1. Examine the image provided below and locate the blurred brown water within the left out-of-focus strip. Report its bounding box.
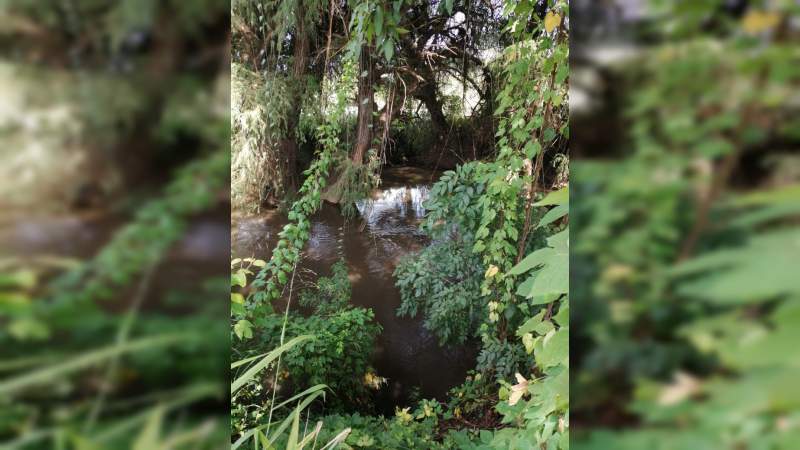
[0,207,230,312]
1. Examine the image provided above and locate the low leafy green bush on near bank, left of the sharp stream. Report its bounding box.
[232,260,380,433]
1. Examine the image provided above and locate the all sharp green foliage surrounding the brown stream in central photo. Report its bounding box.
[231,0,569,449]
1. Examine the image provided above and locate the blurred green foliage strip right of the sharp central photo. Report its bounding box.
[570,0,800,450]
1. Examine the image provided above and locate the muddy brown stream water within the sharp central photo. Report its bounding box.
[231,168,476,413]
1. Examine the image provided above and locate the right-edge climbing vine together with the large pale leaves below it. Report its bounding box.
[473,1,569,448]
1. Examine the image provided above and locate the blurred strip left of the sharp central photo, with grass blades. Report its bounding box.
[0,0,230,449]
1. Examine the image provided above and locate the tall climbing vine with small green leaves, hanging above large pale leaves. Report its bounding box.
[473,1,569,333]
